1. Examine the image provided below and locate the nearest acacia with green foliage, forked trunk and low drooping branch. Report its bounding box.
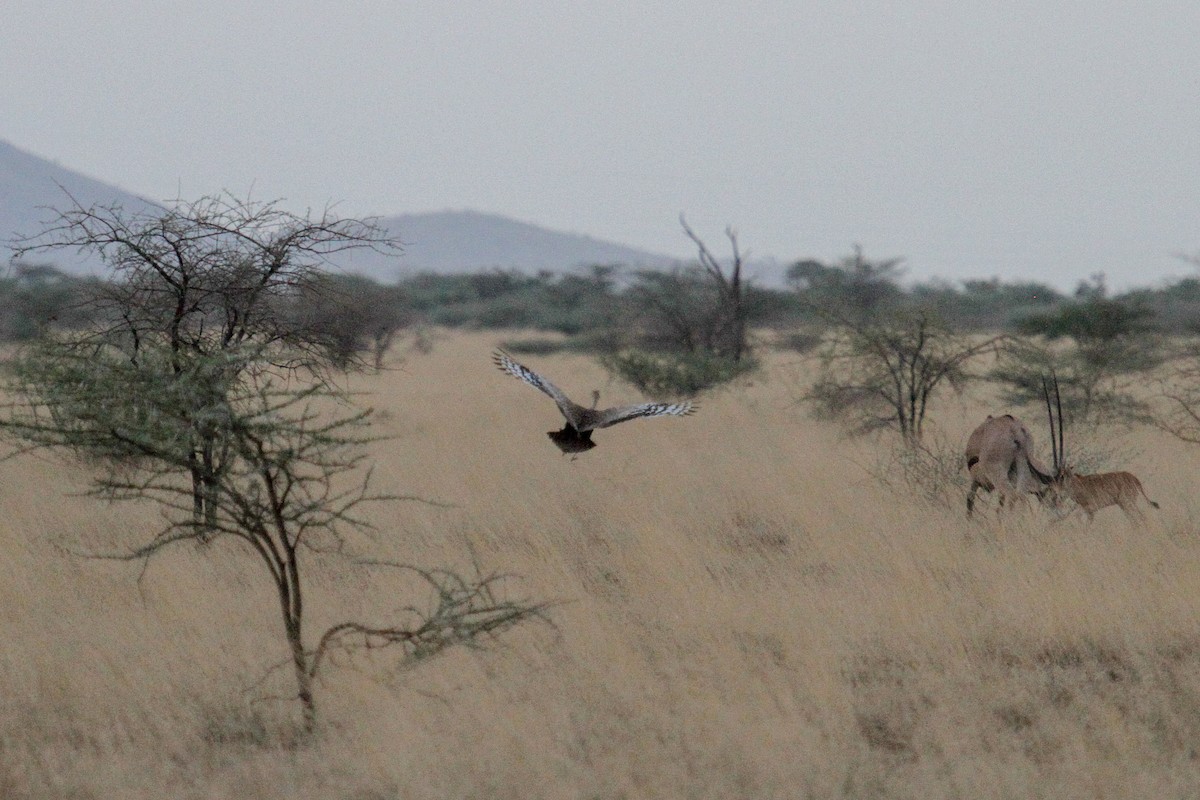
[0,342,544,730]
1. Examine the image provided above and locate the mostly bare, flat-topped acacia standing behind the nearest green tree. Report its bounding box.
[13,194,400,527]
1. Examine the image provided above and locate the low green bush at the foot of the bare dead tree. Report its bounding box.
[600,350,757,401]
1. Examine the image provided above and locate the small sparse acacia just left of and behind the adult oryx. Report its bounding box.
[804,311,1006,445]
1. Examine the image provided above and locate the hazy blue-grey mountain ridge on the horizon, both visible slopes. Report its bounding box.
[0,140,678,283]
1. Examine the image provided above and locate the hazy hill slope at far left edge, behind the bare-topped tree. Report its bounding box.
[0,140,159,271]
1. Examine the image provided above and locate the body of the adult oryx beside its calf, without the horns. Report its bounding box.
[966,414,1054,517]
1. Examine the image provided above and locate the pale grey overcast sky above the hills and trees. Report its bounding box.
[0,0,1200,288]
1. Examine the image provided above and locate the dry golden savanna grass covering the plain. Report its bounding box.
[7,333,1200,800]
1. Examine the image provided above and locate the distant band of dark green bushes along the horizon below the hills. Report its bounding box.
[28,241,1200,352]
